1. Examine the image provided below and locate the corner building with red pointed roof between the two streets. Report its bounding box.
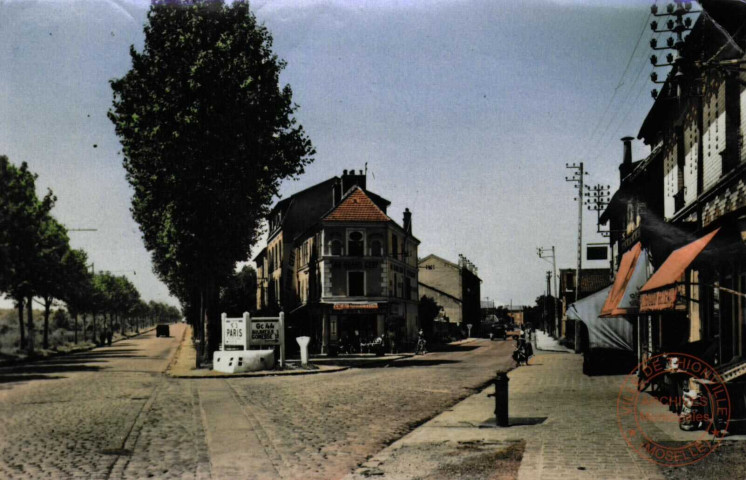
[256,171,419,352]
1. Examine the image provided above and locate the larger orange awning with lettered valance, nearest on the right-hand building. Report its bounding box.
[640,228,720,313]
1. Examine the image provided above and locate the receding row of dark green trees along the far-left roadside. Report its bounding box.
[0,156,181,353]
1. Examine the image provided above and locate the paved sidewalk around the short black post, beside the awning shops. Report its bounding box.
[346,348,672,480]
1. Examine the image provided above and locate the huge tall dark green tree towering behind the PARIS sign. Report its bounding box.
[109,0,314,363]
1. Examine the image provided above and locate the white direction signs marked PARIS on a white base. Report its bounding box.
[213,312,285,373]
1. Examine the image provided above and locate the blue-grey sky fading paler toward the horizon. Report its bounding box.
[0,0,654,305]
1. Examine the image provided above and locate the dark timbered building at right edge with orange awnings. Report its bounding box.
[602,0,746,374]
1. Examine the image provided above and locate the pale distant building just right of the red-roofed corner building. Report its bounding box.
[419,255,482,332]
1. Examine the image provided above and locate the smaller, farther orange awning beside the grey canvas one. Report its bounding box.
[600,242,648,317]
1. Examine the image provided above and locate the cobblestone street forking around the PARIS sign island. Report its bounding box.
[0,325,512,478]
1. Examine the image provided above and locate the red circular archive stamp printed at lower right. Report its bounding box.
[617,353,731,467]
